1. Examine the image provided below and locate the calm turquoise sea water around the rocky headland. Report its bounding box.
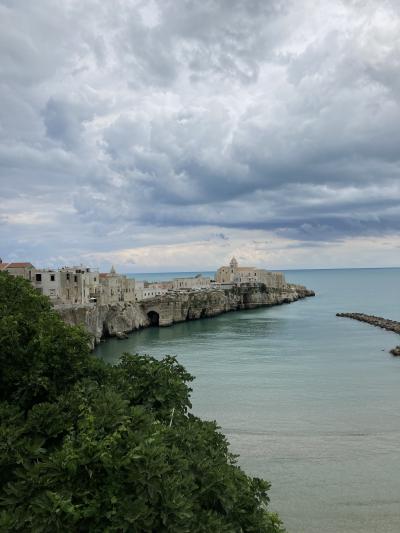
[97,269,400,533]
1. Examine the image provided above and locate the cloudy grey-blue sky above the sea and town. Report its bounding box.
[0,0,400,272]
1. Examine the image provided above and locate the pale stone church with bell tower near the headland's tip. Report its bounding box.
[215,257,286,288]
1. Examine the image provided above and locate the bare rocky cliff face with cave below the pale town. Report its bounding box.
[55,284,315,347]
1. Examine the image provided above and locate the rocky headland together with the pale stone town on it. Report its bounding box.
[0,258,314,347]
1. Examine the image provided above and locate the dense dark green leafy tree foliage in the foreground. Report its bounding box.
[0,273,283,533]
